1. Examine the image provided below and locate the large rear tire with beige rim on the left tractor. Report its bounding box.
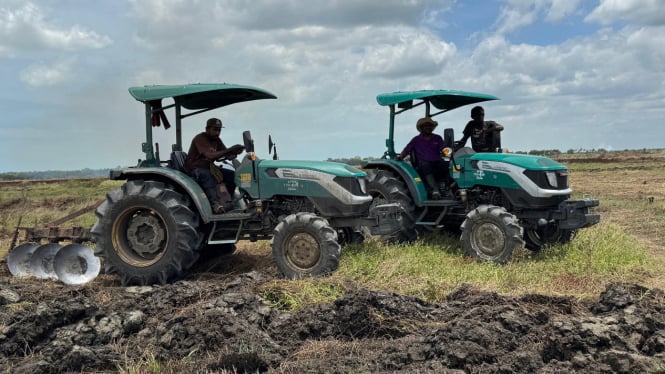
[92,180,202,286]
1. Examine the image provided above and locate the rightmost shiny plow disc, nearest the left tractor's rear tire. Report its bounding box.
[53,244,101,284]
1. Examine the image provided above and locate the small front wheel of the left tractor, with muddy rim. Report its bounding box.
[270,213,341,279]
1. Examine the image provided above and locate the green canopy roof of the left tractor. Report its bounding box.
[129,83,277,110]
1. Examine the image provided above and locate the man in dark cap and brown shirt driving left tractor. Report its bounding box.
[185,118,245,214]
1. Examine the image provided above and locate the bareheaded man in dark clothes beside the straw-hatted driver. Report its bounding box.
[455,106,503,152]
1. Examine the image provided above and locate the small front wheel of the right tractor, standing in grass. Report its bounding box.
[461,205,524,264]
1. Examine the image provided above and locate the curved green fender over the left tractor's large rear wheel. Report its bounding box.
[109,167,212,223]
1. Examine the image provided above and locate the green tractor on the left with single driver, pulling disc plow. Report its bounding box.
[91,84,401,285]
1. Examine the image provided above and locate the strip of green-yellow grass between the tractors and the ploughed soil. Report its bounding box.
[256,224,662,311]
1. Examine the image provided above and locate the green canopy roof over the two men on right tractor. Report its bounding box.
[376,90,499,112]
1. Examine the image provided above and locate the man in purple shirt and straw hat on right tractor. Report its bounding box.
[396,117,450,200]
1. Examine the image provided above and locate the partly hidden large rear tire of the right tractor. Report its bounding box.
[367,169,418,243]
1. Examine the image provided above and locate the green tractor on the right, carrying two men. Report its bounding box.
[365,90,600,263]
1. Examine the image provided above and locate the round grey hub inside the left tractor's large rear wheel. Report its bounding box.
[127,213,165,257]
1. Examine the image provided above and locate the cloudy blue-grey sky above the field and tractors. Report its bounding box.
[0,0,665,172]
